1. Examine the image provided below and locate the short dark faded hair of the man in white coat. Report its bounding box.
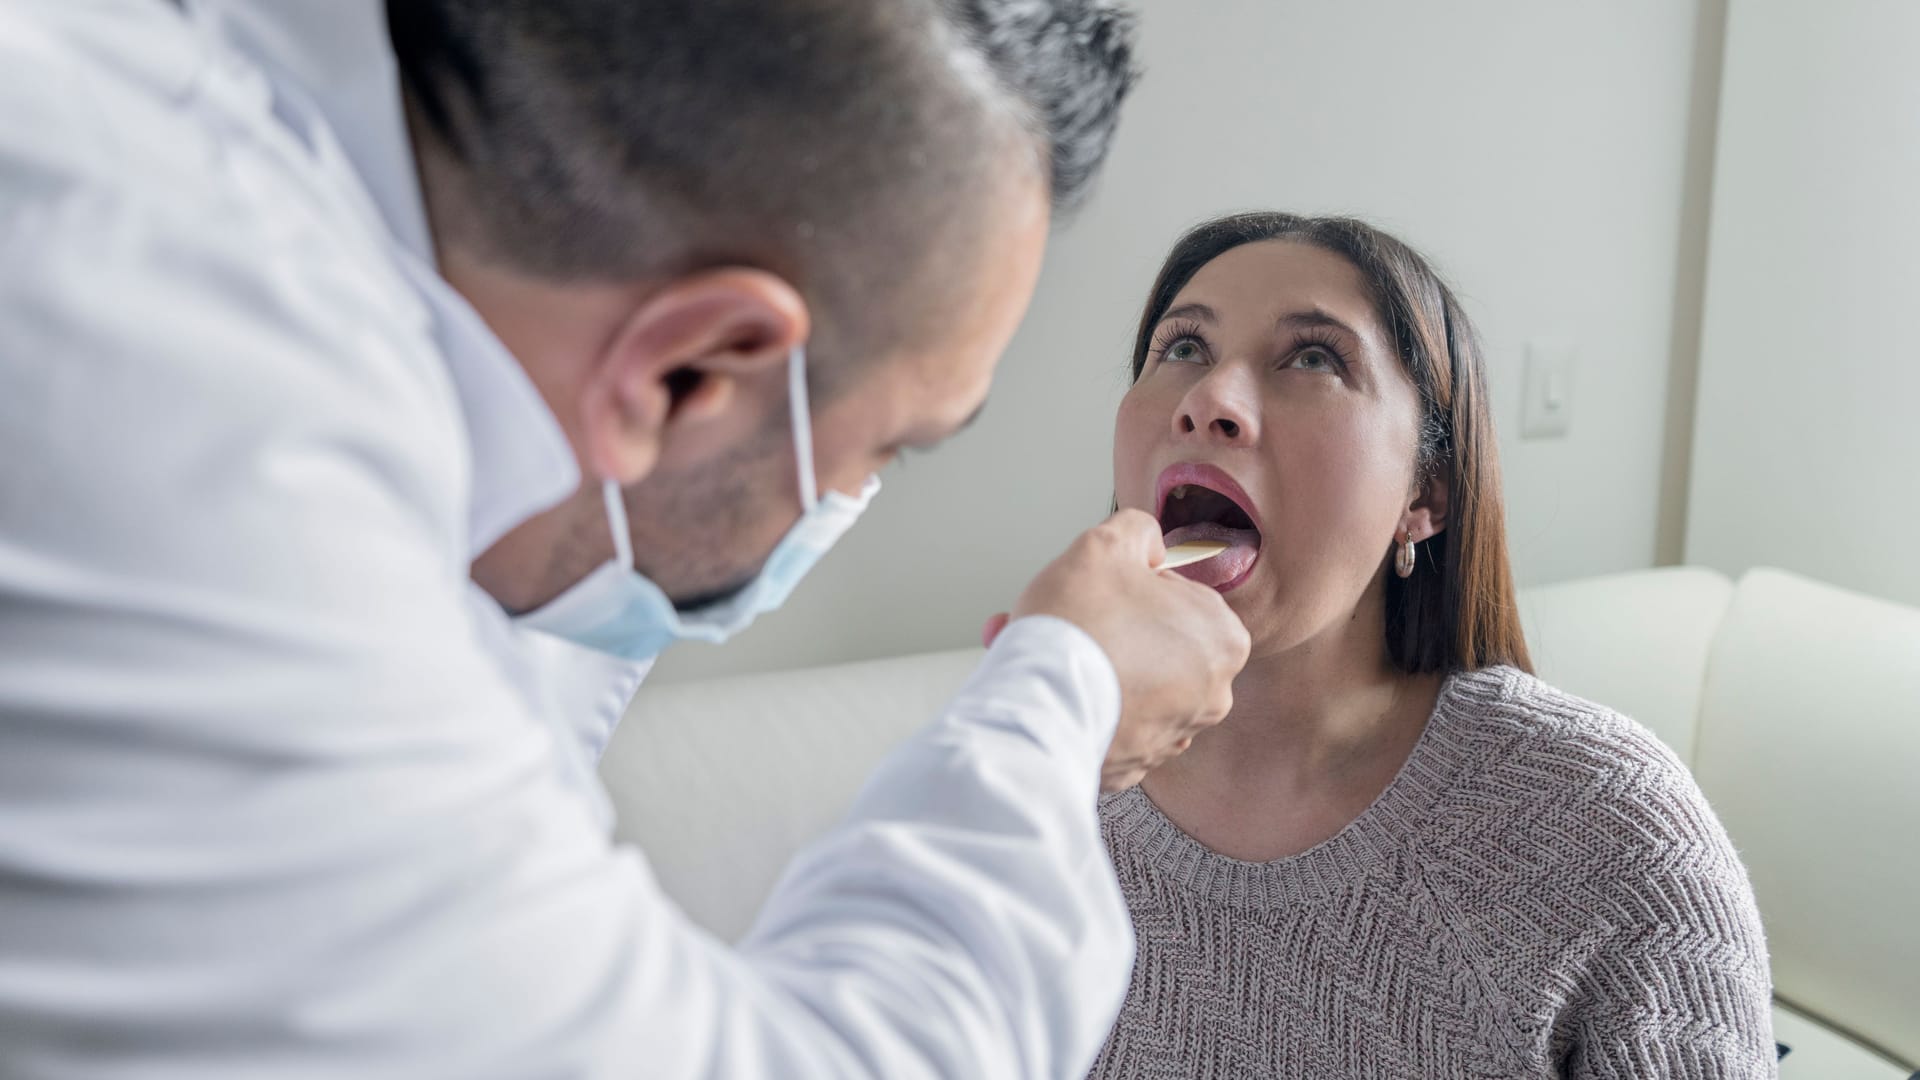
[388,0,1135,374]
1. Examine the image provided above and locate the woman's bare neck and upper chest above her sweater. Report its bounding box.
[1144,588,1442,861]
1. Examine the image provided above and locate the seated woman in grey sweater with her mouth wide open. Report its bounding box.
[1092,213,1774,1080]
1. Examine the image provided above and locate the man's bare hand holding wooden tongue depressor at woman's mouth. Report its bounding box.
[985,509,1252,792]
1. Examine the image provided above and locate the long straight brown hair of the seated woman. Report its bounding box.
[1133,211,1532,673]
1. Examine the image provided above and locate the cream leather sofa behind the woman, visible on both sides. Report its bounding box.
[601,567,1920,1080]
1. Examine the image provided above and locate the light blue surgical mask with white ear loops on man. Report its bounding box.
[518,348,879,659]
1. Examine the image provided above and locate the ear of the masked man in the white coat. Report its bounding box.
[580,267,808,486]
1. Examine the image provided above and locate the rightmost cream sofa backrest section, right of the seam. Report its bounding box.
[1693,571,1920,1061]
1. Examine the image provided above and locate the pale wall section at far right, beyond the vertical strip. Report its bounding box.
[1688,0,1920,603]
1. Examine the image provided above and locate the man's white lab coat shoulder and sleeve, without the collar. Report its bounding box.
[0,16,1131,1080]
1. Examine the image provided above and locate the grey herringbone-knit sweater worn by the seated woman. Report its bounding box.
[1092,667,1776,1080]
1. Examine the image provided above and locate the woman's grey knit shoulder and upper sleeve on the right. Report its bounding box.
[1413,669,1770,1063]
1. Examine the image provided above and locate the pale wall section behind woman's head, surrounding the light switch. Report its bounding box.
[655,0,1718,680]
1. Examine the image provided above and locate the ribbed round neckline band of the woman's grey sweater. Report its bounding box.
[1102,667,1519,907]
